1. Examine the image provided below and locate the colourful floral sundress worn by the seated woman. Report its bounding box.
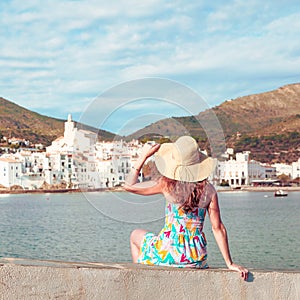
[138,202,208,269]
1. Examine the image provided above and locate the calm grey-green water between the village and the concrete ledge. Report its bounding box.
[0,192,300,269]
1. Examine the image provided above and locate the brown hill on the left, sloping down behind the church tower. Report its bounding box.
[0,97,115,146]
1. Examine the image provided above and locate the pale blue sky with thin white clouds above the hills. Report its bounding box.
[0,0,300,134]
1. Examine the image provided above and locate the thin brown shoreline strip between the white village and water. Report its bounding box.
[0,186,300,195]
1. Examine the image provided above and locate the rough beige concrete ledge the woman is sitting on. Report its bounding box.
[0,259,300,300]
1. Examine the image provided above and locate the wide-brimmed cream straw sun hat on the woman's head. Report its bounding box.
[155,136,217,182]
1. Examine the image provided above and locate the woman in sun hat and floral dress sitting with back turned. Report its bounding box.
[124,136,248,280]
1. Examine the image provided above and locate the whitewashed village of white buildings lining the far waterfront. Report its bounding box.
[0,115,300,190]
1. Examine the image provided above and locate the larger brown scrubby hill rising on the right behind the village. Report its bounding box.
[130,84,300,163]
